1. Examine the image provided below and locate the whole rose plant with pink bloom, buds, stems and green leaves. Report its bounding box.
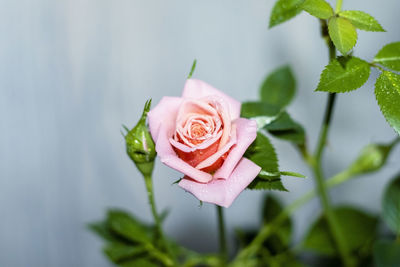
[90,0,400,267]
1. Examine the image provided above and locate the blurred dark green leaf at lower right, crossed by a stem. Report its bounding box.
[303,207,378,256]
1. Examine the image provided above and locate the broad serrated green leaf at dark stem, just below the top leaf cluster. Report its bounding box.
[316,57,371,93]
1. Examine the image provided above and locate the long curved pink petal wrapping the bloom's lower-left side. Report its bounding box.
[156,124,212,183]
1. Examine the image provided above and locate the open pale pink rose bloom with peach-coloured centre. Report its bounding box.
[148,79,261,207]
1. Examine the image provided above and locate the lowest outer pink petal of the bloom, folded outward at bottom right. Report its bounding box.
[179,158,261,208]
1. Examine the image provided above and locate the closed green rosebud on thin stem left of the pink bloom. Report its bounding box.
[125,100,156,176]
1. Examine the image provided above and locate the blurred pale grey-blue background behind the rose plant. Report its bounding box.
[0,0,400,267]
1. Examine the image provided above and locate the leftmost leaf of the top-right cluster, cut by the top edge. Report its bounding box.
[269,0,304,28]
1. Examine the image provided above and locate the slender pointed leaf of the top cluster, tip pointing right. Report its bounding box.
[339,10,385,32]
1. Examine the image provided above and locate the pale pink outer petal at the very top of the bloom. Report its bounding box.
[182,79,241,120]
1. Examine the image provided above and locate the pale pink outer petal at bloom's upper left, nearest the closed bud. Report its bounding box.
[147,96,182,142]
